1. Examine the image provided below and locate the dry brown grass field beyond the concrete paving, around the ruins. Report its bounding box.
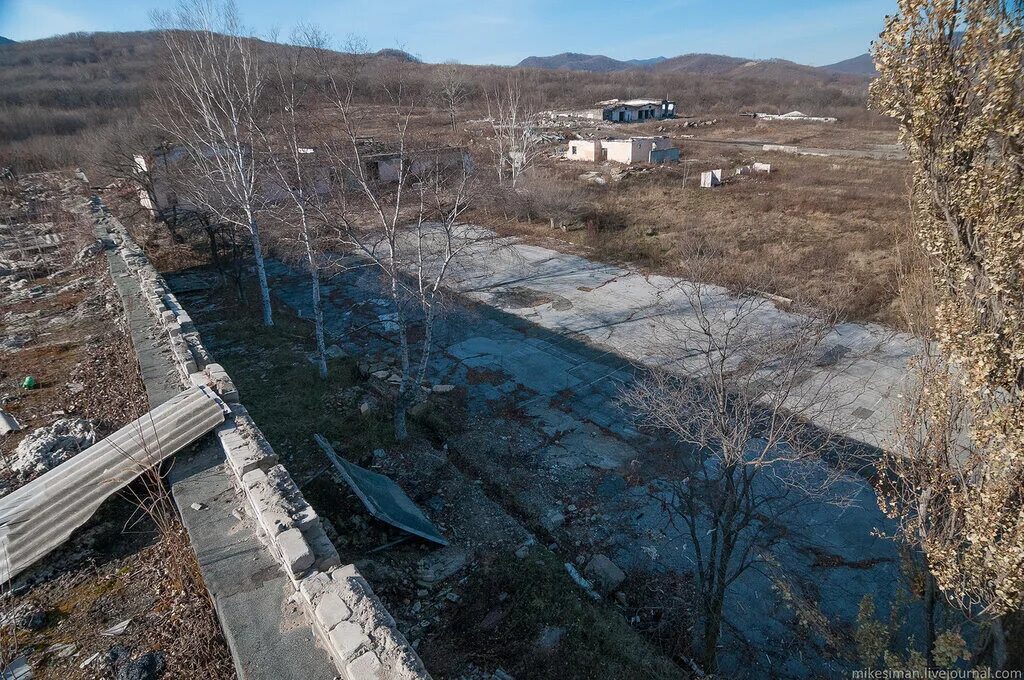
[483,126,913,328]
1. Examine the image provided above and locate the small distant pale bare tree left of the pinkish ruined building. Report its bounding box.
[487,76,542,189]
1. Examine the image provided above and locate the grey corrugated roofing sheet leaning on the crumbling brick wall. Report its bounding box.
[0,387,224,584]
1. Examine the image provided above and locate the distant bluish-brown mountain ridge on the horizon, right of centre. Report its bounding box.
[517,52,878,80]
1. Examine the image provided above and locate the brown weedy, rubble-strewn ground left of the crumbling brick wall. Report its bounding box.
[0,176,233,680]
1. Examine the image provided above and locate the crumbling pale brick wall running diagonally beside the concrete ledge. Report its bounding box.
[100,219,430,680]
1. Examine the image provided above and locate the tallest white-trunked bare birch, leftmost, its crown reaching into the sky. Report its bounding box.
[157,0,273,326]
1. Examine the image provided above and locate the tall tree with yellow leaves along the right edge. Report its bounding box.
[871,0,1024,668]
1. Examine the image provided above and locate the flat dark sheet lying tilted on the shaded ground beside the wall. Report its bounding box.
[313,434,447,546]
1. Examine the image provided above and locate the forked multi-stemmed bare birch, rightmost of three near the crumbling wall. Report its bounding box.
[305,41,487,439]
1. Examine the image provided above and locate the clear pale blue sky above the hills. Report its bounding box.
[0,0,895,66]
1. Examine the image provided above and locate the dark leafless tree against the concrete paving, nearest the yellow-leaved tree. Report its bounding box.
[624,274,847,673]
